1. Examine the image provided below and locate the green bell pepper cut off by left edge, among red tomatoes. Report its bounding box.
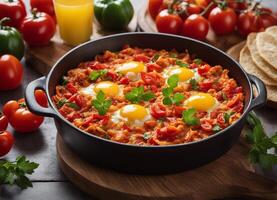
[0,18,25,60]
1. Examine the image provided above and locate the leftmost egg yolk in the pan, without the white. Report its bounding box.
[94,81,119,97]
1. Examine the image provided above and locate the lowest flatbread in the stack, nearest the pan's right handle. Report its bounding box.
[239,46,277,86]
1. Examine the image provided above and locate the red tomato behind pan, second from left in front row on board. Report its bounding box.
[182,14,209,40]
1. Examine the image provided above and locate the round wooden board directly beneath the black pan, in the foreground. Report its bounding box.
[57,134,277,200]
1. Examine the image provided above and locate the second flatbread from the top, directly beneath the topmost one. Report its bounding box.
[247,33,277,79]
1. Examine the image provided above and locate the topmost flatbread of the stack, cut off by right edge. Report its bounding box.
[257,32,277,69]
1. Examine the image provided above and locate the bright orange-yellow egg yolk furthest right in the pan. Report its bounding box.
[184,93,216,111]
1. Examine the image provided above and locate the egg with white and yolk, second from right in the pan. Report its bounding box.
[163,66,201,83]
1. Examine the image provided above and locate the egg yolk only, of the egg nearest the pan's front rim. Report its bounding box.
[120,104,147,121]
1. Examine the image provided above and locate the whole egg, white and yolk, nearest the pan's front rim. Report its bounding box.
[111,104,152,126]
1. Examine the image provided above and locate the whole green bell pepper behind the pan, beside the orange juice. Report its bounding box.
[94,0,134,30]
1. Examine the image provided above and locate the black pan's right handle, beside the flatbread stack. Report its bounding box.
[248,74,267,110]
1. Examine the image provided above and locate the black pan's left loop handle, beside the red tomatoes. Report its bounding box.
[24,76,57,117]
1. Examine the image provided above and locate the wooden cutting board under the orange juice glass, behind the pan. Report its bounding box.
[25,14,137,75]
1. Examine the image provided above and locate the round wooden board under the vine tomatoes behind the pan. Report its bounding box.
[138,4,243,51]
